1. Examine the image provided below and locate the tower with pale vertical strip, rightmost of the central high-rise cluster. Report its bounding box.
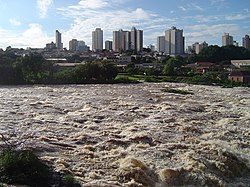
[130,27,143,51]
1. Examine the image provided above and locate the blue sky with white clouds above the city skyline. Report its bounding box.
[0,0,250,49]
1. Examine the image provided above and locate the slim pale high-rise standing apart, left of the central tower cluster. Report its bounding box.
[92,28,103,51]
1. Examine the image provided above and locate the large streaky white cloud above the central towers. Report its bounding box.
[58,0,174,46]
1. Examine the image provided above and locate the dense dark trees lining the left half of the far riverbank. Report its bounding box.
[0,52,118,84]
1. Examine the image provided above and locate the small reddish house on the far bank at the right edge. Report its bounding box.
[228,70,250,84]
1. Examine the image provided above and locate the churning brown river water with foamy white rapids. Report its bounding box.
[0,83,250,187]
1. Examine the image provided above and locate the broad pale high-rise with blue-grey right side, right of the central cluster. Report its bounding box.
[165,27,185,56]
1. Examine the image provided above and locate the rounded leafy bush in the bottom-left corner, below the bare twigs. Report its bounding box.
[0,149,53,187]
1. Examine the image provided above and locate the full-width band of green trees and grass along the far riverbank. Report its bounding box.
[0,46,250,87]
